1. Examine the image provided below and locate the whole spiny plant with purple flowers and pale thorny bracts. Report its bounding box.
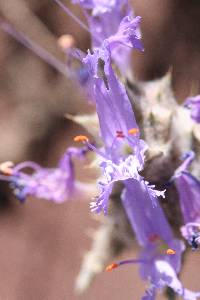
[0,0,200,300]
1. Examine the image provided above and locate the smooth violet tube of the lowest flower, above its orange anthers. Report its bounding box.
[122,179,170,246]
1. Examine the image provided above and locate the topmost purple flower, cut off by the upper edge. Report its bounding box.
[74,0,144,75]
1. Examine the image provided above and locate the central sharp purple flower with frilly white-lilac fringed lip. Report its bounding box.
[84,41,163,213]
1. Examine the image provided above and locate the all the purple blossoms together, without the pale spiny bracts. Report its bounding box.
[0,0,200,300]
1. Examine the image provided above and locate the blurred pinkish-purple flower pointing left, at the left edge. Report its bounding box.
[0,148,87,203]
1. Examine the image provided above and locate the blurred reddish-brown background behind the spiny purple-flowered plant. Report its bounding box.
[0,0,200,300]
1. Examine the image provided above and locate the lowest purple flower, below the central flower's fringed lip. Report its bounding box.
[117,179,200,300]
